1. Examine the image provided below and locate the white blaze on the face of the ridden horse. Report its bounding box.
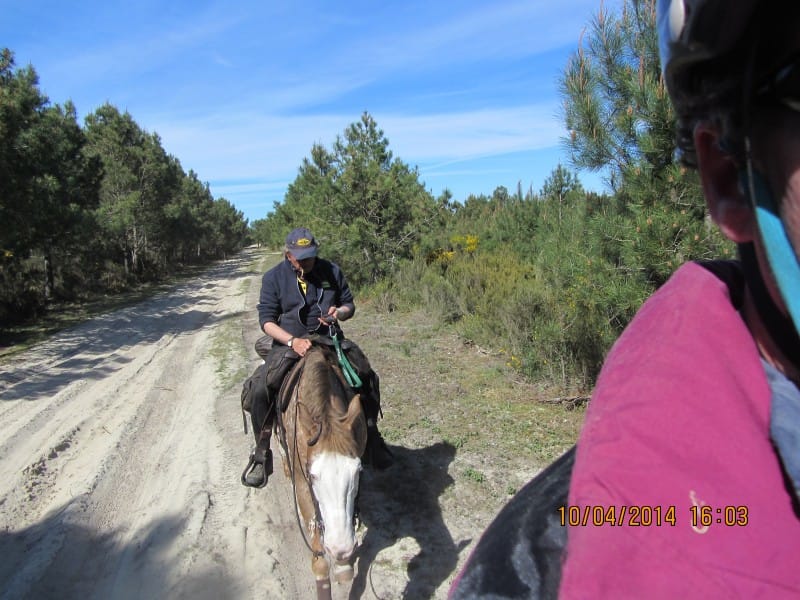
[310,452,361,560]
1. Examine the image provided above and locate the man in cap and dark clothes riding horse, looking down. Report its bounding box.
[242,227,393,487]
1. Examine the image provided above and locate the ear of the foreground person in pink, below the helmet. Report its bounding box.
[694,123,755,244]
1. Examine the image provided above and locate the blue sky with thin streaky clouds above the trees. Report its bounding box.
[0,0,615,222]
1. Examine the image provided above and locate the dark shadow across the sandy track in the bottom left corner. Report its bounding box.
[0,505,243,600]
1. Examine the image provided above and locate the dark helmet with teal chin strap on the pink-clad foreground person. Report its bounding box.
[656,0,800,357]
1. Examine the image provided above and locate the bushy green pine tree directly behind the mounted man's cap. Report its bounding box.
[270,113,438,285]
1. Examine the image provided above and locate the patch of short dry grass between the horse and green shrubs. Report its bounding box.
[354,303,585,488]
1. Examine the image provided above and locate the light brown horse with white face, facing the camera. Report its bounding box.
[275,345,367,599]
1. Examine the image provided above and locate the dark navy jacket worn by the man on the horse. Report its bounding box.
[257,258,356,337]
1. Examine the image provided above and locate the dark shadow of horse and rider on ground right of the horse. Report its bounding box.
[350,442,471,600]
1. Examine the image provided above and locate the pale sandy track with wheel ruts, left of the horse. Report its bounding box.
[0,253,324,599]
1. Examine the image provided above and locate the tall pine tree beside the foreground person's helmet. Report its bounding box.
[560,0,730,287]
